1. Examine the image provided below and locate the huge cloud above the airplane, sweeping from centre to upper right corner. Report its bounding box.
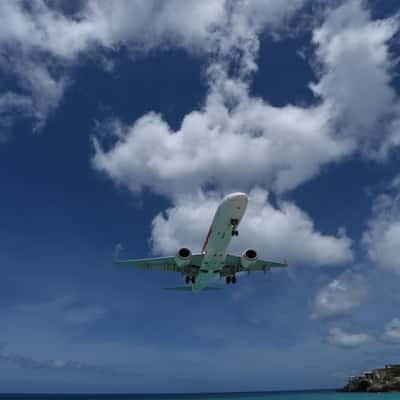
[93,0,398,195]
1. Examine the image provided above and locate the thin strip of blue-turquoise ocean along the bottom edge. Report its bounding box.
[0,390,400,400]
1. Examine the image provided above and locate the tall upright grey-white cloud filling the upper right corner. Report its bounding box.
[312,0,400,157]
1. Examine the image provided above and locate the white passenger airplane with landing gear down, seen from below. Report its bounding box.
[115,193,288,292]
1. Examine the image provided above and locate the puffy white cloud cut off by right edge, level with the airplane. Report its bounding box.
[362,180,400,273]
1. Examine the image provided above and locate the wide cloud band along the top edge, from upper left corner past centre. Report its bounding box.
[0,0,304,134]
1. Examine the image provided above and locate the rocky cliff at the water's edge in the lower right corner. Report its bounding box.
[339,364,400,392]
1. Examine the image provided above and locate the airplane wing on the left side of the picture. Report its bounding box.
[115,254,204,275]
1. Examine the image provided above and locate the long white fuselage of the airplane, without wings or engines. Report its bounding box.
[192,193,248,291]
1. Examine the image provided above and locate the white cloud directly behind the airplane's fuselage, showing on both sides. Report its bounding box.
[152,189,352,266]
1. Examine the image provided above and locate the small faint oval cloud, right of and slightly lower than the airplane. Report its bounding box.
[311,271,368,319]
